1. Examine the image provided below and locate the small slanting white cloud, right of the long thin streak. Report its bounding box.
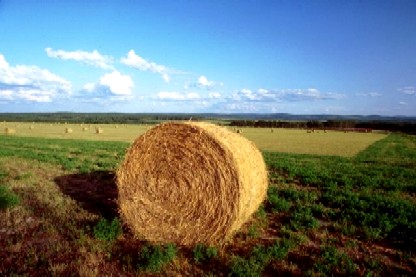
[120,50,175,82]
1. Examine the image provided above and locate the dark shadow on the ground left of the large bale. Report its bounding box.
[54,171,118,219]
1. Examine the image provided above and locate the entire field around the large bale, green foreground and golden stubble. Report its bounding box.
[0,123,416,276]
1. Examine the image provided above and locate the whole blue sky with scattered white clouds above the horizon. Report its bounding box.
[0,0,416,116]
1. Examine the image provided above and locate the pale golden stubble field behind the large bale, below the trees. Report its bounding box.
[0,122,386,157]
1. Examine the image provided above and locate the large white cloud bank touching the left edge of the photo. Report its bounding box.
[0,55,71,102]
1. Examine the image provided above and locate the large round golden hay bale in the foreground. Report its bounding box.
[116,122,268,246]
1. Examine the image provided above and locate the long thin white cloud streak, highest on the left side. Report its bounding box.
[45,48,113,69]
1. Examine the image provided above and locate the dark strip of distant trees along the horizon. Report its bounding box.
[0,112,416,134]
